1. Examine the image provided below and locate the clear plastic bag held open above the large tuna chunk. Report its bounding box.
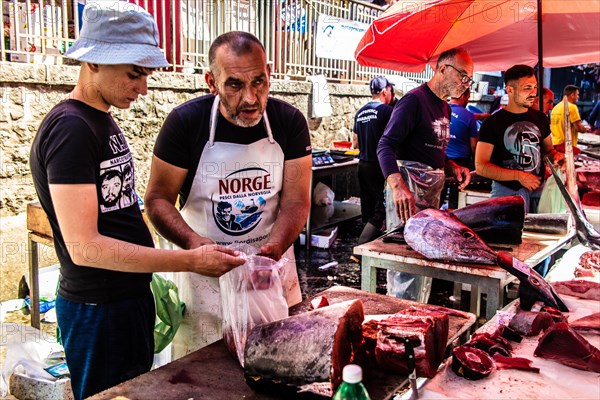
[219,246,289,367]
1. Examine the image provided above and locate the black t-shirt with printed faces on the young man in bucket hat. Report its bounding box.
[30,100,154,303]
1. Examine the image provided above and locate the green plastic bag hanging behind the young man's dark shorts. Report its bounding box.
[150,274,185,354]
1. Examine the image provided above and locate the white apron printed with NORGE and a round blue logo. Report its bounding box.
[173,96,302,359]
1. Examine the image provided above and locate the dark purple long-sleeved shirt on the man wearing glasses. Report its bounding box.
[377,84,450,178]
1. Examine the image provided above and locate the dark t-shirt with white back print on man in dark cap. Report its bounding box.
[354,101,392,165]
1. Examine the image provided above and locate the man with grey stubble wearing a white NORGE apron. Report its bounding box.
[146,32,312,358]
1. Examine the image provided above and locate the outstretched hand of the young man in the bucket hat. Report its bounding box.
[189,244,246,278]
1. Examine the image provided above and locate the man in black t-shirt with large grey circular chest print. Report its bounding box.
[475,65,564,213]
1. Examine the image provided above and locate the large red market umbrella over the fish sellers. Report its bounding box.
[355,0,600,72]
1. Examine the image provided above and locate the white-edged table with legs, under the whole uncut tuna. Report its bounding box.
[354,231,575,320]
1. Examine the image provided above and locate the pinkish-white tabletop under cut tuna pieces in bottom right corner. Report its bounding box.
[419,295,600,399]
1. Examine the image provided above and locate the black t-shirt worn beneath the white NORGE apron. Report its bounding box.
[154,94,312,207]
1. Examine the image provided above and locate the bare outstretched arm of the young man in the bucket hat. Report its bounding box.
[50,184,244,277]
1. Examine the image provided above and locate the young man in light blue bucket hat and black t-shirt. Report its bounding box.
[30,1,243,399]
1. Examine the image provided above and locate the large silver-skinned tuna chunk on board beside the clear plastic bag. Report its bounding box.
[244,300,364,396]
